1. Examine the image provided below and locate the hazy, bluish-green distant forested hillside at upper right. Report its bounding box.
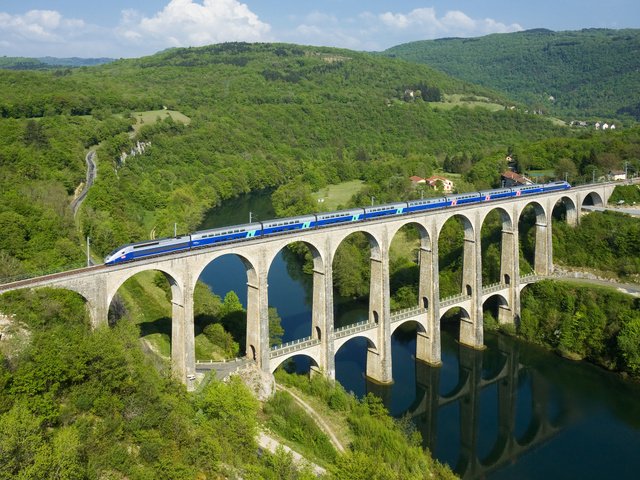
[384,29,640,121]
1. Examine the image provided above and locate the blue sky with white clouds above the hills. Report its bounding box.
[0,0,640,58]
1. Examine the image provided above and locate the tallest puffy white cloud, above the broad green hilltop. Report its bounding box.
[117,0,271,50]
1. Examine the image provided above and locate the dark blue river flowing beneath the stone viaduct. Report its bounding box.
[201,192,640,480]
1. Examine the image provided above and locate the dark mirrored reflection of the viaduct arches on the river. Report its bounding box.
[396,336,568,478]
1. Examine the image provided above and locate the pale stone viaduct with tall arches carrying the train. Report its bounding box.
[0,183,616,388]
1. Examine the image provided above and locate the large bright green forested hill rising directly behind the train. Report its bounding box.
[0,43,567,275]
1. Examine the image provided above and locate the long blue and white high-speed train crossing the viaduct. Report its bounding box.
[104,182,571,265]
